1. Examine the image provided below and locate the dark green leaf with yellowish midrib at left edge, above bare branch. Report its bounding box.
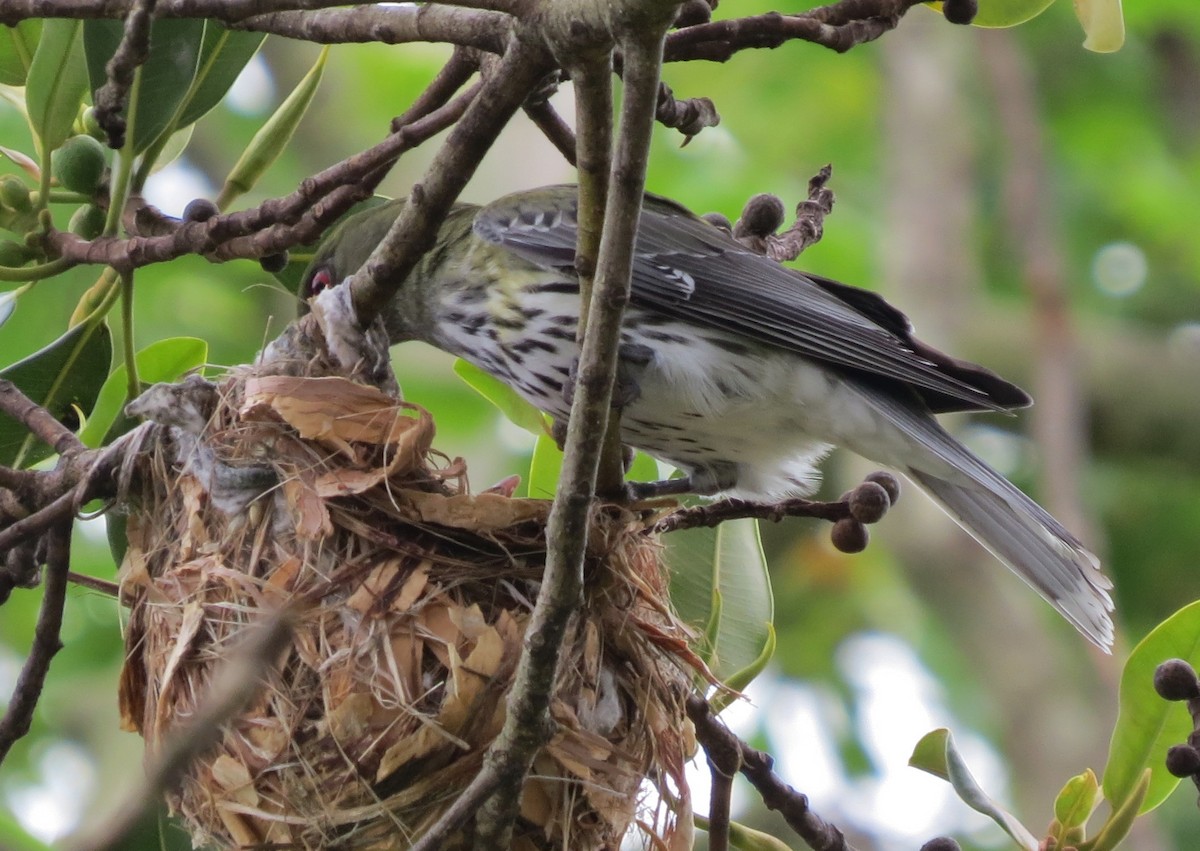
[0,323,113,467]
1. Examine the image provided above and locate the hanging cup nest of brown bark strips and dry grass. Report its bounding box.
[113,331,702,850]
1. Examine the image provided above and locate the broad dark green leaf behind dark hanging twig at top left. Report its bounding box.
[83,18,204,155]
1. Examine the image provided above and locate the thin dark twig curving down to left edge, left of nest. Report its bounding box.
[0,523,71,762]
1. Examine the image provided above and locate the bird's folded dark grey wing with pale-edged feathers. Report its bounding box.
[474,186,1030,410]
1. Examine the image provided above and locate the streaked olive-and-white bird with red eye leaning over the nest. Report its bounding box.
[300,185,1114,652]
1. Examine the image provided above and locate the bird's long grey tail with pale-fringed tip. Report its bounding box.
[854,395,1112,652]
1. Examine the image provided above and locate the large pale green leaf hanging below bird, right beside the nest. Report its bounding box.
[664,520,774,685]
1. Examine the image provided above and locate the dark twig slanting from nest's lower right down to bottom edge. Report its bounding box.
[688,695,854,851]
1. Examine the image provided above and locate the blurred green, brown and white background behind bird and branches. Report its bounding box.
[0,0,1200,851]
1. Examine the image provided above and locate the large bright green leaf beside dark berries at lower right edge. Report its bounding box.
[1103,601,1200,813]
